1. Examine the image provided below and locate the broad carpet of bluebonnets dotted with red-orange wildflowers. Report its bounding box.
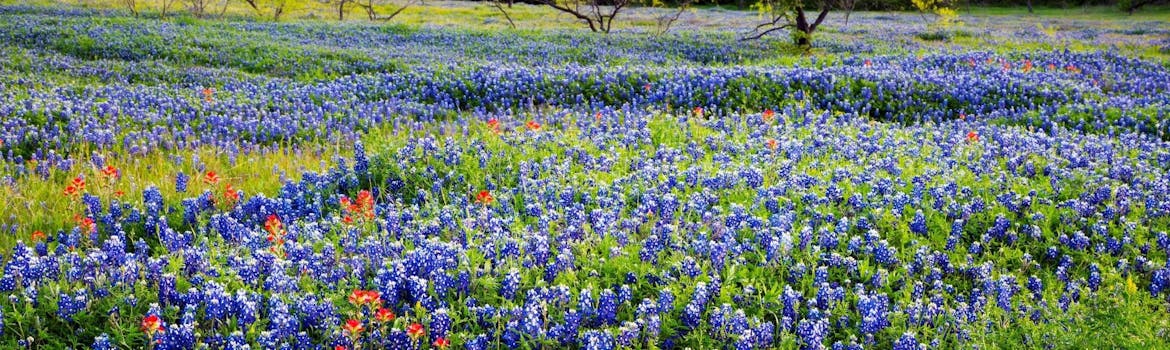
[0,3,1170,350]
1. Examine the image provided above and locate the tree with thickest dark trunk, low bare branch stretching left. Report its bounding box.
[743,0,833,48]
